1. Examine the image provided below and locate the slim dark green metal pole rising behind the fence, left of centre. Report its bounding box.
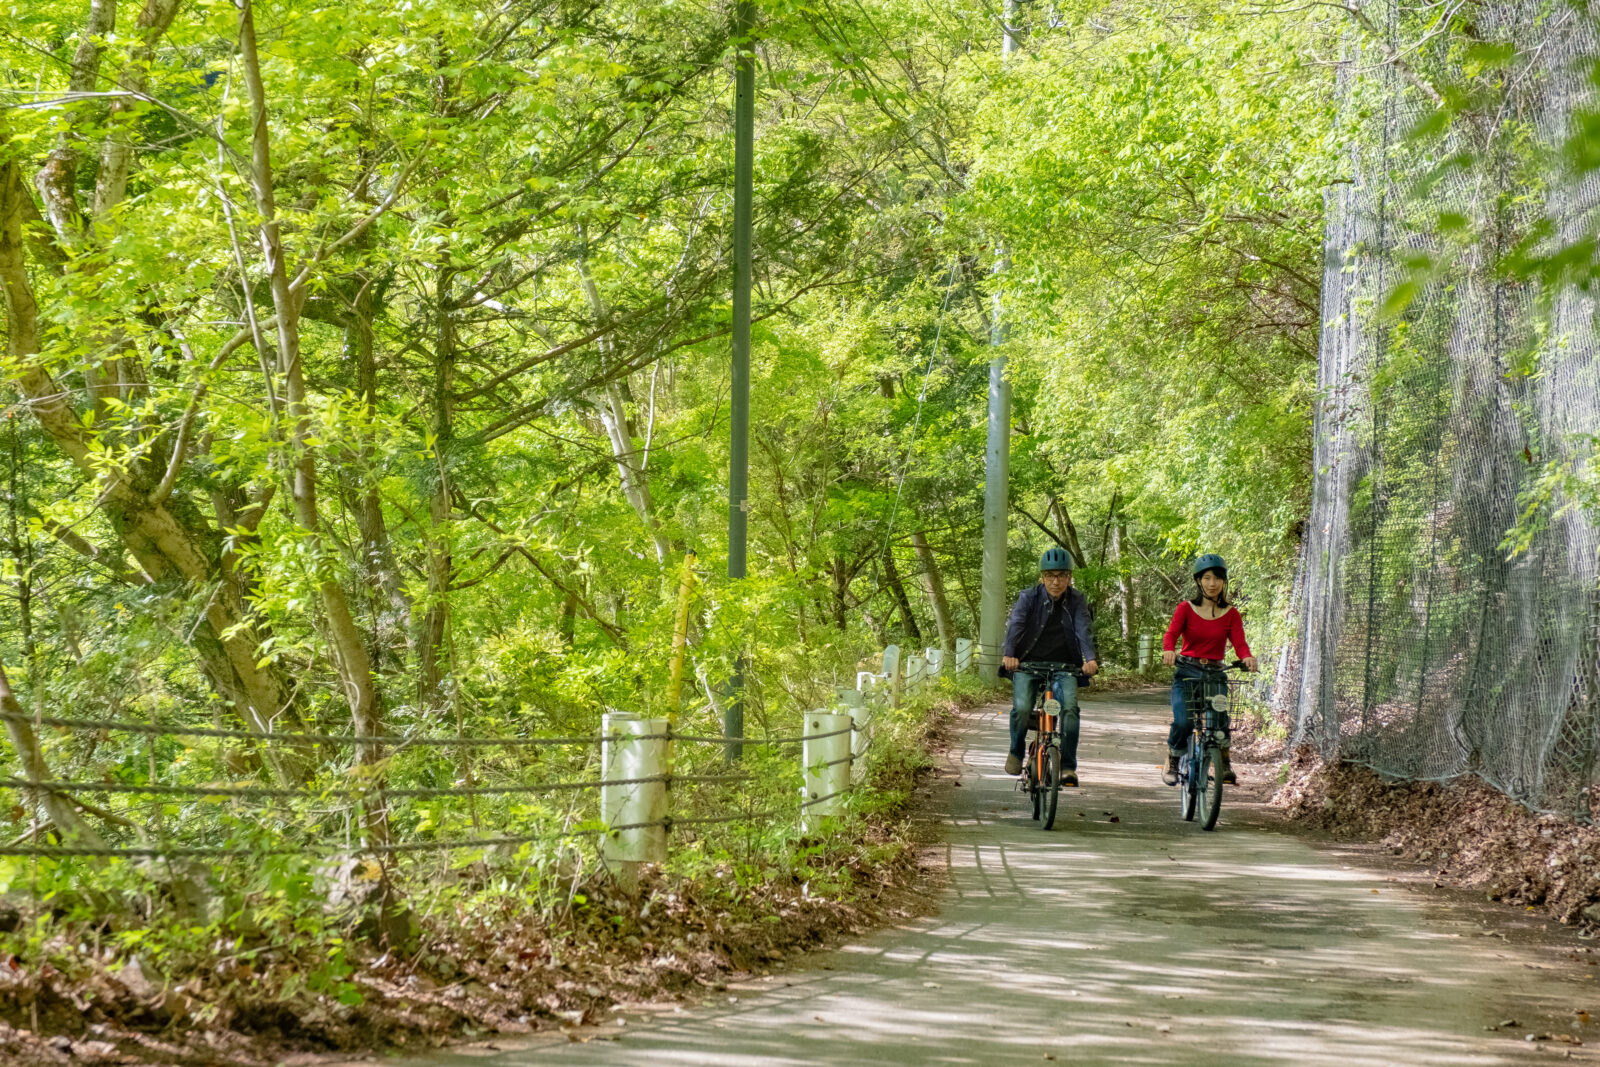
[723,0,755,760]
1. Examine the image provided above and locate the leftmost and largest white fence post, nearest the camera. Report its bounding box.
[600,712,669,883]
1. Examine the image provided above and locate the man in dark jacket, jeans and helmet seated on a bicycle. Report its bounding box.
[1000,547,1099,785]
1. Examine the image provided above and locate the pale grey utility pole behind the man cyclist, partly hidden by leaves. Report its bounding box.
[978,0,1018,681]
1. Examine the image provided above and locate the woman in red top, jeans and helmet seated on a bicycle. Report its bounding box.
[1162,552,1256,785]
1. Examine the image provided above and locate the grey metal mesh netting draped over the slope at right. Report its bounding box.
[1278,5,1600,816]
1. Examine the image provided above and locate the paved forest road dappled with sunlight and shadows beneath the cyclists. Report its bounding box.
[400,696,1600,1067]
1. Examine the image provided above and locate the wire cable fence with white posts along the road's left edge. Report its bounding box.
[0,643,960,864]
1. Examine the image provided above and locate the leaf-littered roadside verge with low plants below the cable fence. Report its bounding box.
[0,691,979,1067]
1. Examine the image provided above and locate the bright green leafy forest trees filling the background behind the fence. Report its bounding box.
[0,0,1339,819]
